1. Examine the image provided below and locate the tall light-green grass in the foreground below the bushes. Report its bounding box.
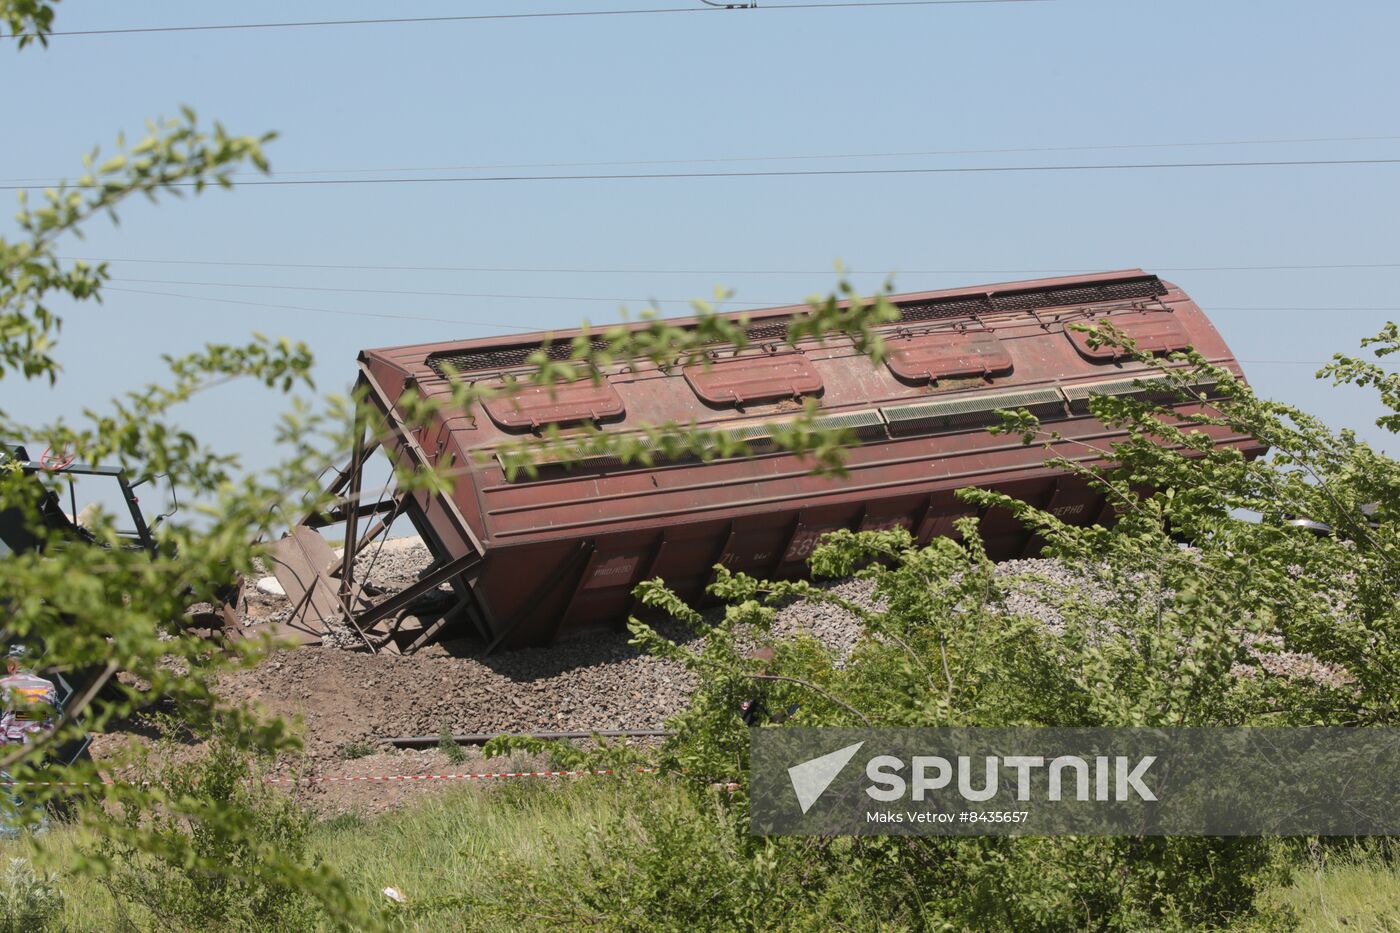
[8,776,1400,933]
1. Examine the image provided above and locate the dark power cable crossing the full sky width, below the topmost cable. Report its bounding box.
[0,158,1400,191]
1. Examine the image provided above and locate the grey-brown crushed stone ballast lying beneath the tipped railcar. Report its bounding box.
[224,538,1345,758]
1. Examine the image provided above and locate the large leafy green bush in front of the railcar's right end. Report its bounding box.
[531,326,1400,930]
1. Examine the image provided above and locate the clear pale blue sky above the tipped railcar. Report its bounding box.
[0,0,1400,465]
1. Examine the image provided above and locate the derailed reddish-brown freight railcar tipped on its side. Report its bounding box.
[352,270,1261,647]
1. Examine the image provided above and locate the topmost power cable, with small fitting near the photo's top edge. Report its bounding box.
[8,0,1054,39]
